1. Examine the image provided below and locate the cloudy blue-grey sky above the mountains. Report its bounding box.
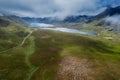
[0,0,120,18]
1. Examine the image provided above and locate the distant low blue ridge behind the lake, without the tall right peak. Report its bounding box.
[22,15,93,23]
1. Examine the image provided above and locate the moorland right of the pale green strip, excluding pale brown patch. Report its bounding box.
[31,30,120,80]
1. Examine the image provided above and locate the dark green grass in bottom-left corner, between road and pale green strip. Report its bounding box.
[0,48,29,80]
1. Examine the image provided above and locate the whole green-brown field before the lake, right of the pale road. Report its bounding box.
[0,29,120,80]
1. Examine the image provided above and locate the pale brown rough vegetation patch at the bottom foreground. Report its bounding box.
[58,57,93,80]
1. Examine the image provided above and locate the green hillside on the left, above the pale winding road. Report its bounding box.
[0,25,29,51]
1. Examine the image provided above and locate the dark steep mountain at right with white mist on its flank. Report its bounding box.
[88,6,120,32]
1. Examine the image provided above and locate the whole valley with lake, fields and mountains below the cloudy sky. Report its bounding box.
[0,4,120,80]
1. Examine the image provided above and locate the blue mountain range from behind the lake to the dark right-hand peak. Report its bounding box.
[22,6,120,23]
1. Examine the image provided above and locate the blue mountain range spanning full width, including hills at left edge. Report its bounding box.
[0,6,120,29]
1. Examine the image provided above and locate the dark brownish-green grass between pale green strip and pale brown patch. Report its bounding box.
[31,31,61,80]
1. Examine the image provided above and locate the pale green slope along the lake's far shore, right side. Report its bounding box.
[54,19,119,39]
